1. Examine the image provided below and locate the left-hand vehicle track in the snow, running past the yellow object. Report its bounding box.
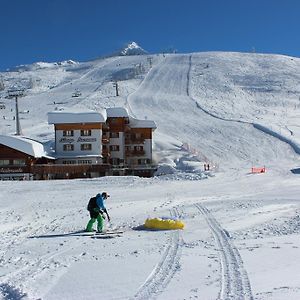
[132,208,182,299]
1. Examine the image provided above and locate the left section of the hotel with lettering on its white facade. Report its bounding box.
[46,109,110,178]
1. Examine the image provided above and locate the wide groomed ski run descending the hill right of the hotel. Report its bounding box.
[129,55,295,168]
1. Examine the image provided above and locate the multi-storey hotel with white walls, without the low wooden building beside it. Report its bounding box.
[48,107,156,178]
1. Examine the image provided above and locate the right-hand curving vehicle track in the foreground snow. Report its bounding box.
[195,203,253,300]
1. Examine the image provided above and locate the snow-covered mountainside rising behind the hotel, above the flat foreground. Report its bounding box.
[0,50,300,170]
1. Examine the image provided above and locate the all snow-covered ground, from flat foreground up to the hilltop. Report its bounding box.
[0,52,300,300]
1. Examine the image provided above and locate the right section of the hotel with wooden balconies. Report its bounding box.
[103,107,156,177]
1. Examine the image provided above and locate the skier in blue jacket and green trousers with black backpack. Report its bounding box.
[86,192,110,232]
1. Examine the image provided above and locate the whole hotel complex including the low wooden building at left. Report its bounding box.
[0,107,156,179]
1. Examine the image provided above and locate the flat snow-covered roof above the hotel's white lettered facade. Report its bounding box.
[48,109,107,124]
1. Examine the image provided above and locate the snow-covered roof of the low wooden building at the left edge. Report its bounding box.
[0,135,48,158]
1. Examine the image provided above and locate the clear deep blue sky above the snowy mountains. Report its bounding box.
[0,0,300,71]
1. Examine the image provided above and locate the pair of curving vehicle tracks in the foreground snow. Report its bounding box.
[133,203,253,300]
